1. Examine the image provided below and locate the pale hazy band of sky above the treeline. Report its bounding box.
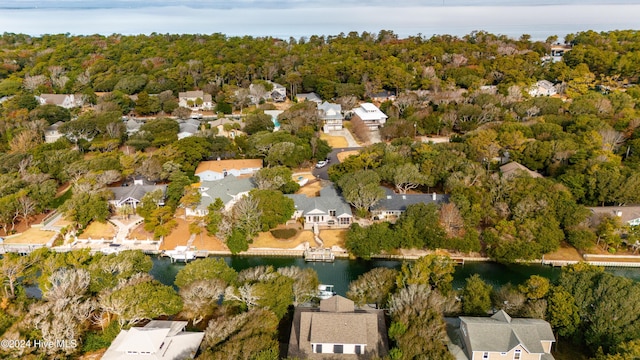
[0,0,640,39]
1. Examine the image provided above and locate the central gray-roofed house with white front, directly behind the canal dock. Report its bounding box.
[285,185,353,229]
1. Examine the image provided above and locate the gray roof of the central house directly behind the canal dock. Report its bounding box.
[285,186,353,217]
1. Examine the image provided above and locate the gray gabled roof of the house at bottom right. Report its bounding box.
[460,310,555,354]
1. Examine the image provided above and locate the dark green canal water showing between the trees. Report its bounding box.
[151,256,640,295]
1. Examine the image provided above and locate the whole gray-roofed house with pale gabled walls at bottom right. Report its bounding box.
[447,310,555,360]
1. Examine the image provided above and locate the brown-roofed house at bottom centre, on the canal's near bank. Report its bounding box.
[288,295,388,359]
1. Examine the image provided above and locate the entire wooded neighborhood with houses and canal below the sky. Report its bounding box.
[0,30,640,360]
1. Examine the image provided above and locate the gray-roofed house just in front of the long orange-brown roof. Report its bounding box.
[186,175,256,216]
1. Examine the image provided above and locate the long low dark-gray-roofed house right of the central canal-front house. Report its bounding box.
[371,187,449,219]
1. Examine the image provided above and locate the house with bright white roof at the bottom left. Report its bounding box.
[102,320,204,360]
